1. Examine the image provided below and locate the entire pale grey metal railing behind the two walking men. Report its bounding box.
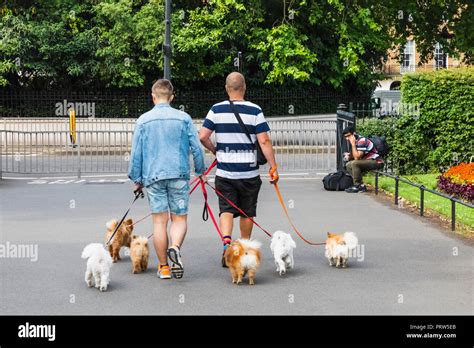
[0,120,337,177]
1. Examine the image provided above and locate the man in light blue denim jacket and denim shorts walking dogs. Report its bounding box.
[128,79,206,279]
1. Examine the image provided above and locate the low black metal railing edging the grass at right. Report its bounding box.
[374,170,474,231]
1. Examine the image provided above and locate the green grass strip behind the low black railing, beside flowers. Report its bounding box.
[365,173,474,229]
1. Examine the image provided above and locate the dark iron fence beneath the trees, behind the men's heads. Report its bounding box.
[0,86,370,118]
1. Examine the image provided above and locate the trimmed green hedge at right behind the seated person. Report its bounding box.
[358,67,474,174]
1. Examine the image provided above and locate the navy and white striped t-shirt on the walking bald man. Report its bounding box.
[203,100,270,179]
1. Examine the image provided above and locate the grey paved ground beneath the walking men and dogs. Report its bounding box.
[0,178,474,315]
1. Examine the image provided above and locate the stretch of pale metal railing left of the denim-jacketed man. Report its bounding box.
[0,131,133,177]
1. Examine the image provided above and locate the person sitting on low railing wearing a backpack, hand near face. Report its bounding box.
[342,126,384,193]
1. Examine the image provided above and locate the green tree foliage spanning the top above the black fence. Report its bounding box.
[0,0,474,89]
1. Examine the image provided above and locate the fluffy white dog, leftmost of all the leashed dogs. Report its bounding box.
[82,243,112,291]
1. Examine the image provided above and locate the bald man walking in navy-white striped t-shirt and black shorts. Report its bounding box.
[199,72,278,267]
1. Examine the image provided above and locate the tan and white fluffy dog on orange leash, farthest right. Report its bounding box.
[325,232,359,268]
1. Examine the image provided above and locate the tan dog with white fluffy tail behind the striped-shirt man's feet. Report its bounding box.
[224,239,262,285]
